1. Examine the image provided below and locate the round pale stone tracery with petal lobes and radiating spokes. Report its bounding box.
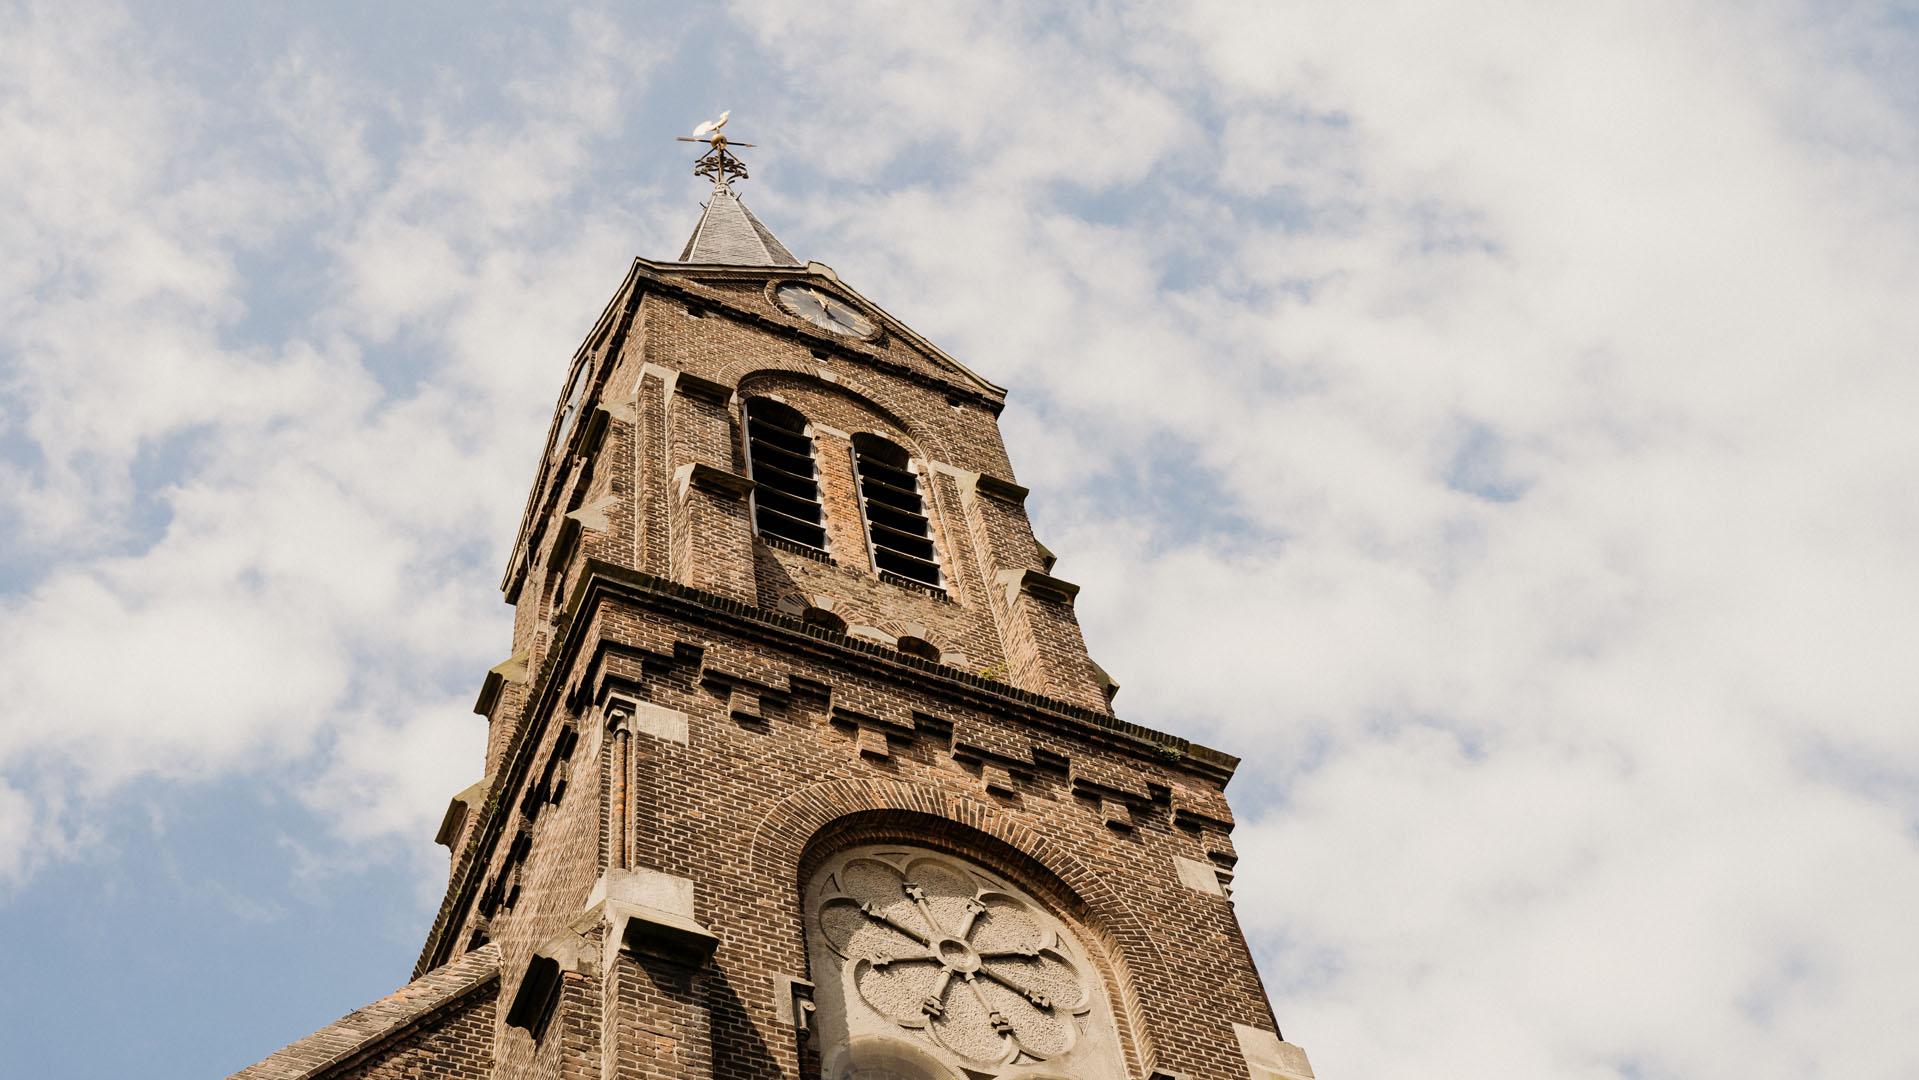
[819,856,1092,1065]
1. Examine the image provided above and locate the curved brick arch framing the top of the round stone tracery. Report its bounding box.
[750,779,1167,1068]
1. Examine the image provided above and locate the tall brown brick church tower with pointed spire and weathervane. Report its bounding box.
[240,119,1313,1080]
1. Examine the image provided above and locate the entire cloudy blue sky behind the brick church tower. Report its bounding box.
[0,2,1919,1080]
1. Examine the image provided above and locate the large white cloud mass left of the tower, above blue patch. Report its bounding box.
[0,8,660,880]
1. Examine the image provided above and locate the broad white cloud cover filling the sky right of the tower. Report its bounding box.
[740,4,1919,1076]
